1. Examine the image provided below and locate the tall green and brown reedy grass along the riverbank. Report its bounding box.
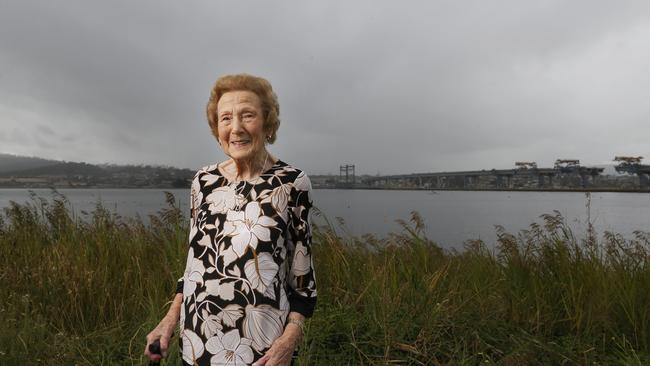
[0,192,650,365]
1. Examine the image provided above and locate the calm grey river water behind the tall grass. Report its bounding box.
[0,188,650,248]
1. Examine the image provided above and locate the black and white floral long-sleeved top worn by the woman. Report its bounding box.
[177,160,316,365]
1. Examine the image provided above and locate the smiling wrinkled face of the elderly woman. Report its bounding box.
[217,90,265,161]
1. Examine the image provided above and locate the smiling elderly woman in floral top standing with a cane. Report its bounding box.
[145,74,316,366]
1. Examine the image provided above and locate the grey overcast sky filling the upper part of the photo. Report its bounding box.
[0,0,650,174]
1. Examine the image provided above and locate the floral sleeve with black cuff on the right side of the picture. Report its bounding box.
[287,172,316,317]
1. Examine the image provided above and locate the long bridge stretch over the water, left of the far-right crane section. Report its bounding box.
[364,159,604,190]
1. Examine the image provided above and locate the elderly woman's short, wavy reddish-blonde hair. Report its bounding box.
[206,74,280,144]
